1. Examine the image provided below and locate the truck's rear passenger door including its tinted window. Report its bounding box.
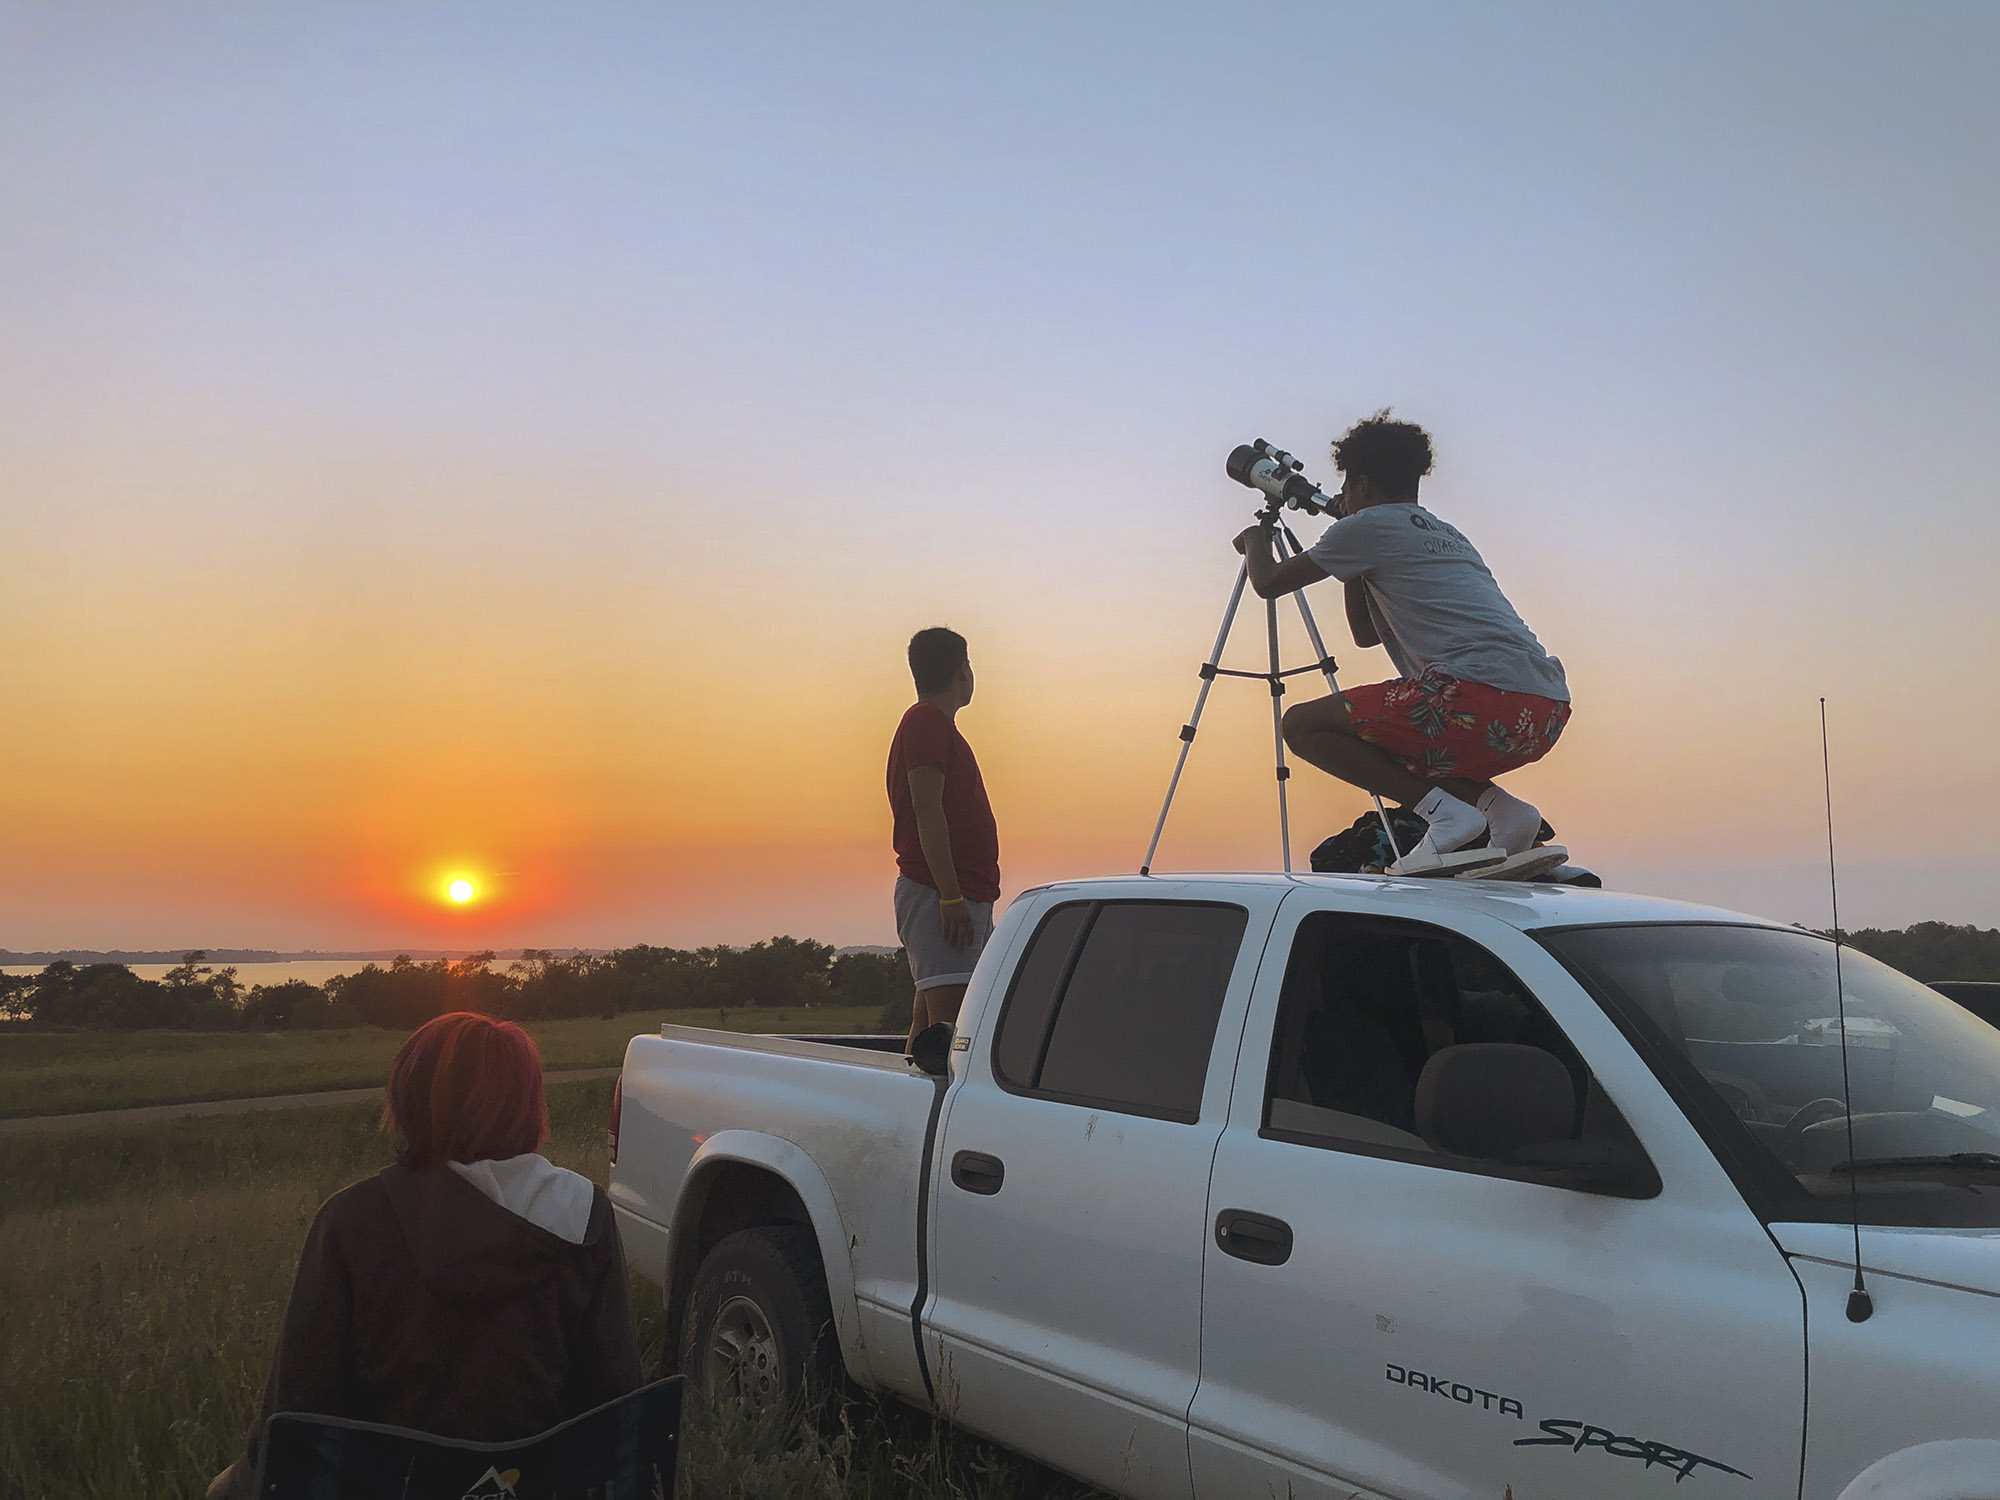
[926,882,1282,1500]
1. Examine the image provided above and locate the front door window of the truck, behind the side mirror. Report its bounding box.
[1264,912,1636,1170]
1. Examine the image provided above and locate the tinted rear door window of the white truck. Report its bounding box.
[994,902,1248,1120]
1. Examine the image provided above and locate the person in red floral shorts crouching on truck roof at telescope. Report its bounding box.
[1236,408,1570,874]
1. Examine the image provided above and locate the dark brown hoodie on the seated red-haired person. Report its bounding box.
[242,1166,640,1478]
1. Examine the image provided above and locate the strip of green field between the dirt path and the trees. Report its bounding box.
[0,1006,878,1118]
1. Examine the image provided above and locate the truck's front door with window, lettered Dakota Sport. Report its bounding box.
[1190,908,1804,1500]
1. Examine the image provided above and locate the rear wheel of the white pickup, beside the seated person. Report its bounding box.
[680,1224,840,1412]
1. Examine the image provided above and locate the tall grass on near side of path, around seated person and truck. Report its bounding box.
[0,1080,1096,1500]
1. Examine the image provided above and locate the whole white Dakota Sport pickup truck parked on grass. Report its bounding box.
[610,876,2000,1500]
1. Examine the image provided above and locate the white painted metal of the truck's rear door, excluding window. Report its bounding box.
[924,880,1286,1500]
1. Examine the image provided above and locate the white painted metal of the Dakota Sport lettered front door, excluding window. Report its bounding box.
[1190,900,1806,1500]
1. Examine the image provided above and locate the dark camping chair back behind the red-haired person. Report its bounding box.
[256,1376,682,1500]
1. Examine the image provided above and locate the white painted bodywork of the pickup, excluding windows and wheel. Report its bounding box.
[612,876,2000,1500]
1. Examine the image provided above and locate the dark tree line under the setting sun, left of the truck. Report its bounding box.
[0,938,914,1030]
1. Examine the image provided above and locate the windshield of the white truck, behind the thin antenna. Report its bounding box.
[1536,924,2000,1226]
